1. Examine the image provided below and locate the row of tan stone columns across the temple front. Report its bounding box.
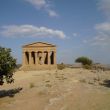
[23,51,56,65]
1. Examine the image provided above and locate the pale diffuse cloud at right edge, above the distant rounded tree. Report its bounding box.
[83,22,110,46]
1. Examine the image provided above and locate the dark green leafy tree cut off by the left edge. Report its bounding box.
[0,46,16,85]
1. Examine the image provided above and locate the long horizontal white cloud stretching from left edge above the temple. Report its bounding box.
[0,25,66,39]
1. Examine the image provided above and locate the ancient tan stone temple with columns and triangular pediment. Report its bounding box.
[22,42,57,70]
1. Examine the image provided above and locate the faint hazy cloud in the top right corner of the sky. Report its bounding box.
[97,0,110,18]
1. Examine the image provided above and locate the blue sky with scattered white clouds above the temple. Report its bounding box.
[0,0,110,64]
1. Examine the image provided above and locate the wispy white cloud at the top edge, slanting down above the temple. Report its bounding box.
[25,0,58,17]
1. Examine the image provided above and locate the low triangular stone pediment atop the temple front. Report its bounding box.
[23,42,55,47]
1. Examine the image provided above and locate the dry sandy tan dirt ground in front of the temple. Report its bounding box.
[0,68,110,110]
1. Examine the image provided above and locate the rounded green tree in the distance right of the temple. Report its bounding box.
[75,57,92,65]
